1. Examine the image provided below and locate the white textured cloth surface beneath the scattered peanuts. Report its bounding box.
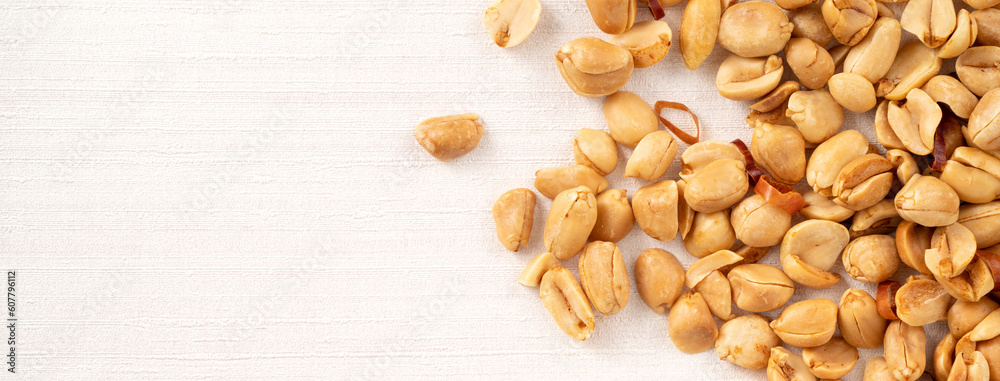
[0,0,948,380]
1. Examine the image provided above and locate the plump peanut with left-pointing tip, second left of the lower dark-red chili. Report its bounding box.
[771,299,837,348]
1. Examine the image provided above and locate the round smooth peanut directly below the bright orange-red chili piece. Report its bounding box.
[730,194,792,247]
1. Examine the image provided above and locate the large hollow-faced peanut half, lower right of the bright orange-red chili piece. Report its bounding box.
[780,220,850,288]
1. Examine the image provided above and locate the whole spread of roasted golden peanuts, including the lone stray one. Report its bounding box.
[415,0,1000,381]
